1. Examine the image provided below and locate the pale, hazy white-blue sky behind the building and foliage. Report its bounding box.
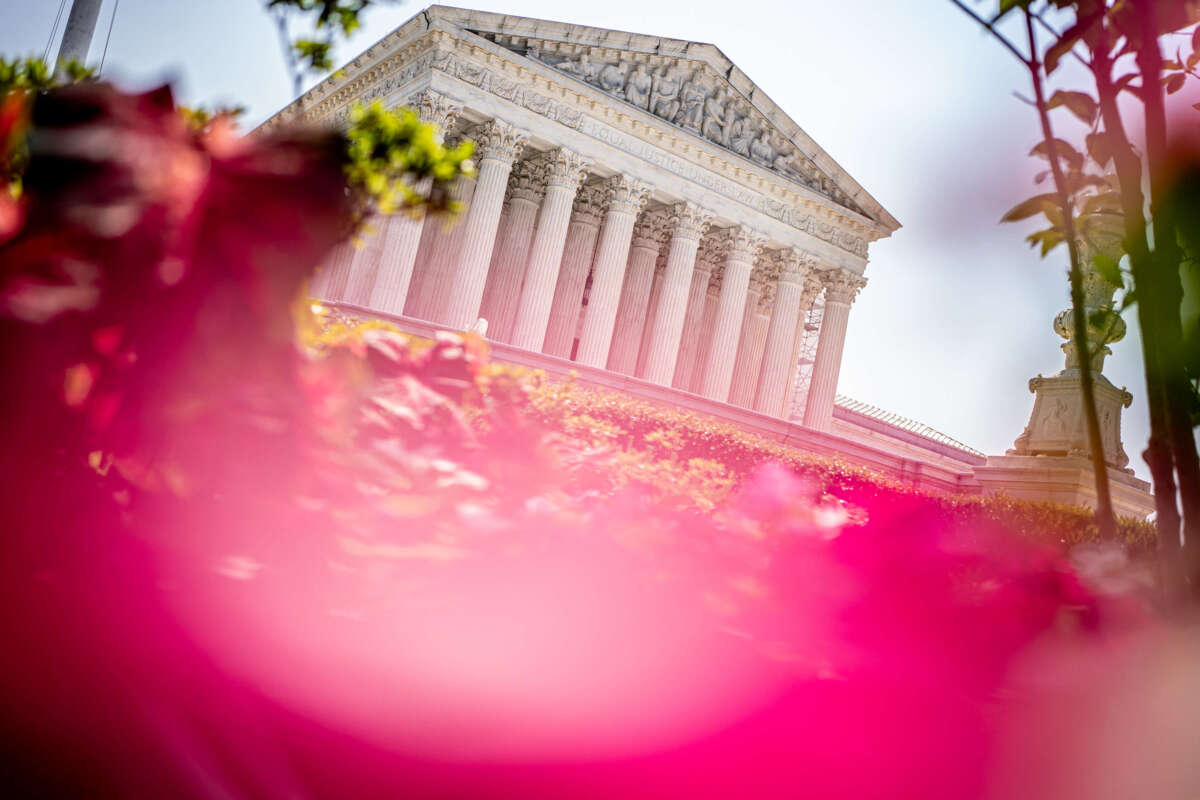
[0,0,1148,477]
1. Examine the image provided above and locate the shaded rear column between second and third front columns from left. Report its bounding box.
[479,157,546,342]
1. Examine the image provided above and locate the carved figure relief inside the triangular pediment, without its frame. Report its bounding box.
[470,34,862,212]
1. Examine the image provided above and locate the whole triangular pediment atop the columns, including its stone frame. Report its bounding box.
[426,6,899,230]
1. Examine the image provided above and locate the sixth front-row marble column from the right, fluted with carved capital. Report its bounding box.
[510,149,588,351]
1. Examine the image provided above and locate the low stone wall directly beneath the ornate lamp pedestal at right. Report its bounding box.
[974,456,1154,519]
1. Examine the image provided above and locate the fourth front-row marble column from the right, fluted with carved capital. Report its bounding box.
[646,203,713,386]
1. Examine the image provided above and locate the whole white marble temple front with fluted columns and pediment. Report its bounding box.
[278,6,899,432]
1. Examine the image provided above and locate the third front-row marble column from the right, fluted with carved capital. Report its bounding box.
[700,225,767,402]
